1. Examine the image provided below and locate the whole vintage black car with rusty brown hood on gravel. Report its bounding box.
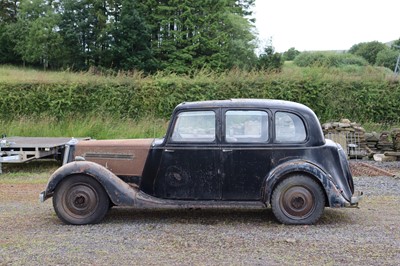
[40,99,362,224]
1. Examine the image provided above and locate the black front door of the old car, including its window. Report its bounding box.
[157,109,222,200]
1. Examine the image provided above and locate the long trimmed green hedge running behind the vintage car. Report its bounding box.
[0,73,400,123]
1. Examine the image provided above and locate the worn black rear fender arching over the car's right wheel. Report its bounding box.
[262,160,350,207]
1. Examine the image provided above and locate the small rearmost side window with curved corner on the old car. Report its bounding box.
[275,112,306,143]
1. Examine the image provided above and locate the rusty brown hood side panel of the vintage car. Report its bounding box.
[75,139,154,176]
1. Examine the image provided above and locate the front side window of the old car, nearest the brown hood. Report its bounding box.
[171,111,215,142]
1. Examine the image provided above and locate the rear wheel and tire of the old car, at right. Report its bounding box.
[271,175,325,224]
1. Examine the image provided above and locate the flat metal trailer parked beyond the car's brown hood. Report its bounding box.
[0,137,85,174]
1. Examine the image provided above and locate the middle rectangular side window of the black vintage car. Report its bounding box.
[225,110,269,143]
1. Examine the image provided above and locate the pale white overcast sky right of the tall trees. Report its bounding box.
[254,0,400,52]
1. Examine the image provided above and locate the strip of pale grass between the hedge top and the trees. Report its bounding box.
[0,61,395,84]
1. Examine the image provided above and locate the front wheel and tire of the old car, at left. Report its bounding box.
[53,175,110,225]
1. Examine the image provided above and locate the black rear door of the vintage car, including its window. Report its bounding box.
[221,109,272,200]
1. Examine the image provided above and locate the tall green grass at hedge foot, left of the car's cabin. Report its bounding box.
[0,116,167,139]
